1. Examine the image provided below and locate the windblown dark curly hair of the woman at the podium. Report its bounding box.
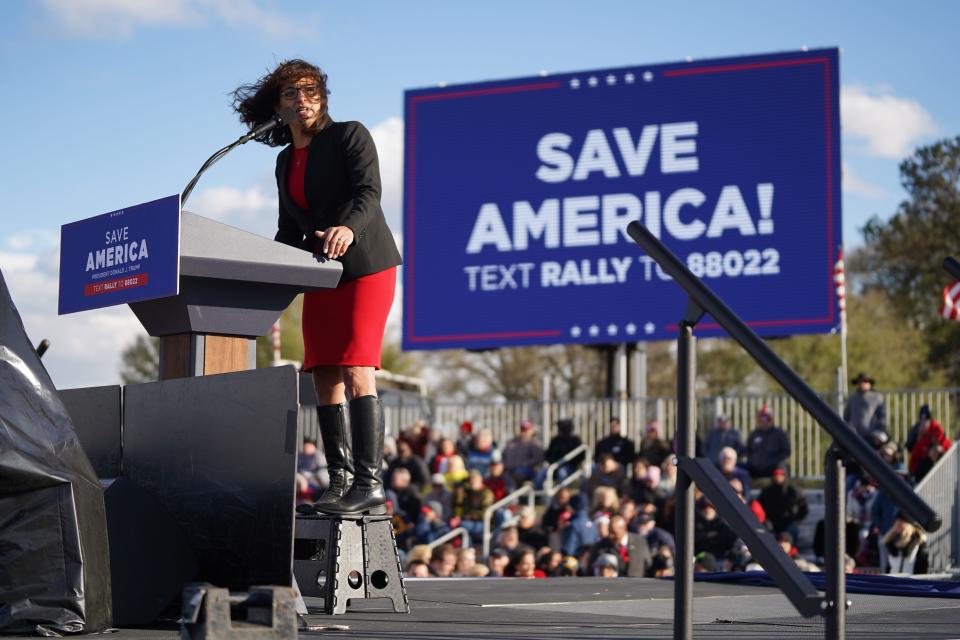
[233,59,330,147]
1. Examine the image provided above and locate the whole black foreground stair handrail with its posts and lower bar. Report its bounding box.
[627,221,942,640]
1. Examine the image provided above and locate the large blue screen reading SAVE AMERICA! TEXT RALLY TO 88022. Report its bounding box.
[403,49,841,349]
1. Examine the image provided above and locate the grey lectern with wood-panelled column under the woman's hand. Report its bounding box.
[130,211,342,380]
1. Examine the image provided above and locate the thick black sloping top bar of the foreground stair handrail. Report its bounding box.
[627,221,940,531]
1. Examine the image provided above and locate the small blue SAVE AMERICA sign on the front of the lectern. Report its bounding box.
[58,195,180,315]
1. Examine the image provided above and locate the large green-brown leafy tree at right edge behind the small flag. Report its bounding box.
[861,136,960,379]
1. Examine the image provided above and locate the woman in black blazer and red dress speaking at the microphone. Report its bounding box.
[234,60,401,514]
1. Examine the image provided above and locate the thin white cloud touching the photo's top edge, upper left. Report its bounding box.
[42,0,310,39]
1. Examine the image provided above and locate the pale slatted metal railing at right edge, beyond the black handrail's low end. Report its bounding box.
[914,443,960,573]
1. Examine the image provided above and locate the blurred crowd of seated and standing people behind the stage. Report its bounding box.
[298,374,950,578]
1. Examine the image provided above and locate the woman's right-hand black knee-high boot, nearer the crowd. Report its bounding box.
[317,396,386,515]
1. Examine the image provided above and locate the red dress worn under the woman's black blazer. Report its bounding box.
[287,142,397,371]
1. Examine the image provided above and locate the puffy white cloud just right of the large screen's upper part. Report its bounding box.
[840,85,937,159]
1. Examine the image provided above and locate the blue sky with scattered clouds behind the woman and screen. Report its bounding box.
[0,0,960,387]
